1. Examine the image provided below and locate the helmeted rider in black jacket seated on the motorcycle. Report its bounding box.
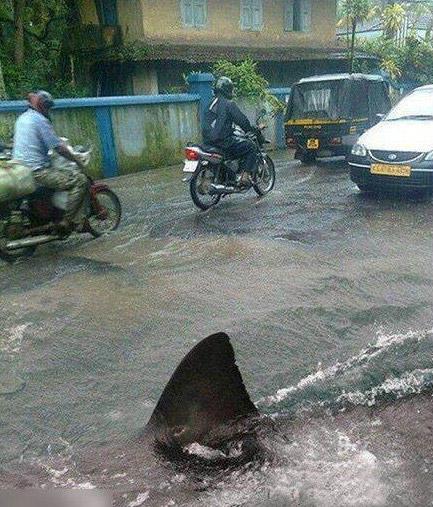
[203,77,257,183]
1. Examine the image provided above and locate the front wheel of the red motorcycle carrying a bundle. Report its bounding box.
[87,189,122,238]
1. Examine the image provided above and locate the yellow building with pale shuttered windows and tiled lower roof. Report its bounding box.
[79,0,345,95]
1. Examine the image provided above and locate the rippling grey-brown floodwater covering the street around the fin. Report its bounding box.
[0,154,433,507]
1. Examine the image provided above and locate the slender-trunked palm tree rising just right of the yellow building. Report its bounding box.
[338,0,378,72]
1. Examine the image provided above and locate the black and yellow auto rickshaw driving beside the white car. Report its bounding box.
[285,74,391,163]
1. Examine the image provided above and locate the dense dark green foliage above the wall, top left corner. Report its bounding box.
[0,0,86,98]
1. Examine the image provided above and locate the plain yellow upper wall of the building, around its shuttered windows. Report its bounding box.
[132,0,336,47]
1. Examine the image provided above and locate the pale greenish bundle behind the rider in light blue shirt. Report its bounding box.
[0,161,36,202]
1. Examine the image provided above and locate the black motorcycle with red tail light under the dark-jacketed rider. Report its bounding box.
[183,117,275,211]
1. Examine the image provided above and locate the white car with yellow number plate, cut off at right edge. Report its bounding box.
[349,85,433,191]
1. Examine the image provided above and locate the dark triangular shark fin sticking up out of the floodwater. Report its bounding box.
[145,333,258,447]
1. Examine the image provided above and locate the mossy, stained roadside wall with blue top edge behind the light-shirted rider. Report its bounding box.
[0,94,201,178]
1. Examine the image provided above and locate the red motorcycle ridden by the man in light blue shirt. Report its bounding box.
[0,142,122,262]
